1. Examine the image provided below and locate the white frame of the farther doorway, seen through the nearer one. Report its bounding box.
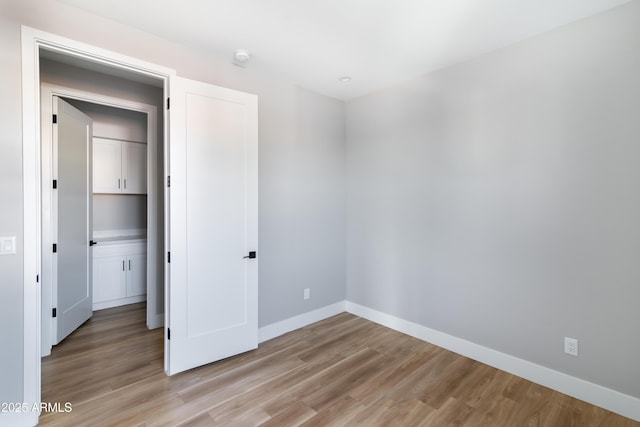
[40,83,162,356]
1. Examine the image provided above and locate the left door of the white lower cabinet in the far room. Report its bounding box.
[93,256,127,303]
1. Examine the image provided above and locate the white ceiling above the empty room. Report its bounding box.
[61,0,630,99]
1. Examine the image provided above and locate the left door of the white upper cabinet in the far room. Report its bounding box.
[93,138,122,193]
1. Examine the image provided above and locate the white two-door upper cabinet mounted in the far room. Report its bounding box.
[93,137,147,194]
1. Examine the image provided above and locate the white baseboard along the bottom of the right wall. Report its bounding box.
[344,301,640,421]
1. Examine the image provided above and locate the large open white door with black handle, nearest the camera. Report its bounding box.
[165,78,258,375]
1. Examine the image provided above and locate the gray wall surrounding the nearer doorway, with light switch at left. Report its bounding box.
[0,0,345,412]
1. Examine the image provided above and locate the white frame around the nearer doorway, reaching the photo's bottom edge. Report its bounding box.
[21,26,176,426]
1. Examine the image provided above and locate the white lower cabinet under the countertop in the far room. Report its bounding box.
[93,243,147,310]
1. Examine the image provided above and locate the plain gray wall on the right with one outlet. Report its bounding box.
[346,2,640,397]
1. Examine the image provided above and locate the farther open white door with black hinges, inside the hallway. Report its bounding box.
[53,96,93,344]
